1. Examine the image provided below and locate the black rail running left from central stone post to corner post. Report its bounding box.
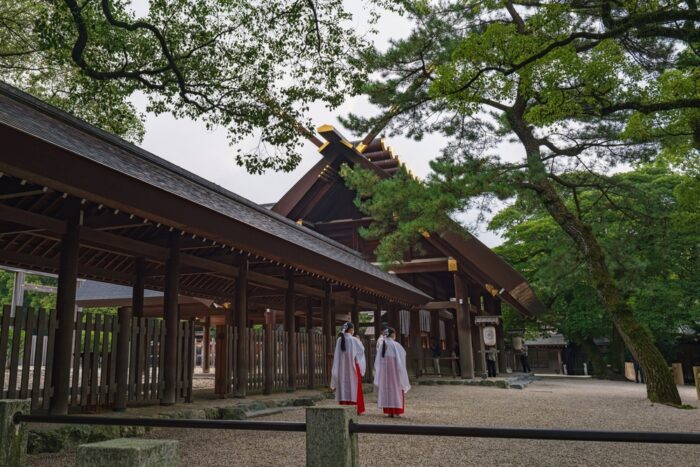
[14,413,306,432]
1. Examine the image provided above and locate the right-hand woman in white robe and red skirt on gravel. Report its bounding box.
[374,328,411,417]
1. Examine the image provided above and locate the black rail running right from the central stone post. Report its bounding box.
[350,422,700,444]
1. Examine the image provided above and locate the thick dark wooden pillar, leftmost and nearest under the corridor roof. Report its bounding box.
[49,203,82,415]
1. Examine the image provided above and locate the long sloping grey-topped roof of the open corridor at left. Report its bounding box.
[0,83,430,304]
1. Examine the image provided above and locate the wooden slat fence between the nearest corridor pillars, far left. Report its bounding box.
[0,306,194,410]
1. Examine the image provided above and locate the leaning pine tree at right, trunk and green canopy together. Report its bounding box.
[344,0,700,404]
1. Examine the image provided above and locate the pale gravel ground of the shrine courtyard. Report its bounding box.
[24,379,700,466]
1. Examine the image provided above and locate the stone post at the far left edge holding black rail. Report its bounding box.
[0,399,31,467]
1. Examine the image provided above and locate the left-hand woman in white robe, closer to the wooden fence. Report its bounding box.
[331,323,367,415]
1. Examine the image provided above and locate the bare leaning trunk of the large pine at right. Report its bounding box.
[507,108,681,405]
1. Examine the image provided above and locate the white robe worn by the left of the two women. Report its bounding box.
[331,333,367,402]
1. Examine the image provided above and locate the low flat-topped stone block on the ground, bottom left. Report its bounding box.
[76,438,180,467]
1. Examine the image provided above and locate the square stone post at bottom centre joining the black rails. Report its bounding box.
[306,406,359,467]
